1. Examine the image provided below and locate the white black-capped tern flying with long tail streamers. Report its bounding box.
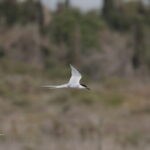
[42,65,90,90]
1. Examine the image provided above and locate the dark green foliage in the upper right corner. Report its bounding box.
[103,1,149,31]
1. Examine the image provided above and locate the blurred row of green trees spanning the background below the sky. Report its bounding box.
[0,0,150,70]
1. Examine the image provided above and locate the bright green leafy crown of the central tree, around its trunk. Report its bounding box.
[50,9,103,49]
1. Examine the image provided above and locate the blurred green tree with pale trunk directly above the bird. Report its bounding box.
[50,8,103,63]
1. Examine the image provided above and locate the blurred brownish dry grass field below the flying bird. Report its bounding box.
[0,60,150,150]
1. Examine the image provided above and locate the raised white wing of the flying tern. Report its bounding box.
[69,65,82,85]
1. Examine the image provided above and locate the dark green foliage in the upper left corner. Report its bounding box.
[0,0,40,26]
